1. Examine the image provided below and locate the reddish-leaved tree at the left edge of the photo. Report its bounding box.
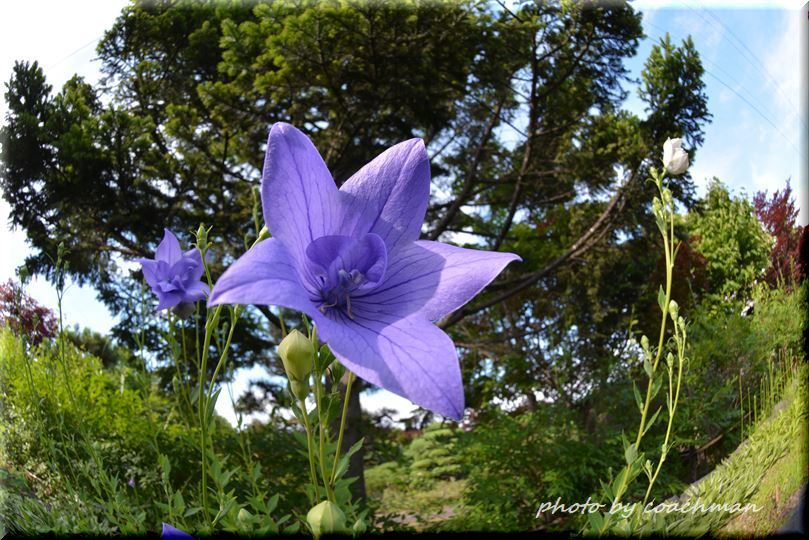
[0,280,57,344]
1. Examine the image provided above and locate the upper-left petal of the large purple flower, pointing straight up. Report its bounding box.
[261,122,340,262]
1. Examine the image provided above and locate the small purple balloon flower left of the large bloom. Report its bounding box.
[138,229,208,311]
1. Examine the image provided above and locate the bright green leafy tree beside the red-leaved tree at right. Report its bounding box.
[689,178,772,302]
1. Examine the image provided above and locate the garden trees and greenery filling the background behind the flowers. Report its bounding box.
[0,2,809,535]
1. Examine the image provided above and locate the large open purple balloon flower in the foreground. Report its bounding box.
[209,123,519,419]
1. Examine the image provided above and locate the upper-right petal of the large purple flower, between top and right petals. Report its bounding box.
[340,139,430,251]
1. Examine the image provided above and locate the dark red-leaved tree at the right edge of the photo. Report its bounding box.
[753,180,803,288]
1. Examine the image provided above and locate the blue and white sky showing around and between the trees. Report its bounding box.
[0,0,809,418]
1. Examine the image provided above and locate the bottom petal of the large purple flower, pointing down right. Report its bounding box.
[314,313,464,420]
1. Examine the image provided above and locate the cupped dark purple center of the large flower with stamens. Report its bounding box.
[306,233,388,319]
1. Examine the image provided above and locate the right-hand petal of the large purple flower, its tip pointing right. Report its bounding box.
[352,240,522,321]
